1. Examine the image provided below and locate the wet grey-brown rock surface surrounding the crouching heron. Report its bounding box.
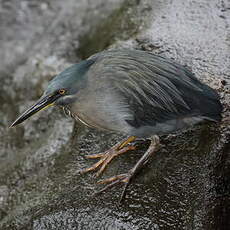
[0,0,230,230]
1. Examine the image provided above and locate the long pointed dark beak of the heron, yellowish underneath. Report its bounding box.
[10,94,60,127]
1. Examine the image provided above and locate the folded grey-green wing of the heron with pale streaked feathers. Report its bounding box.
[87,50,222,128]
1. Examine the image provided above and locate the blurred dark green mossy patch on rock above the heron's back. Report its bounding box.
[77,0,141,59]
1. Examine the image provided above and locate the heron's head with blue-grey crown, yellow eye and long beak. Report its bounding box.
[11,60,93,127]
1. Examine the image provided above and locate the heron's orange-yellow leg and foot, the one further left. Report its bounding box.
[81,136,136,177]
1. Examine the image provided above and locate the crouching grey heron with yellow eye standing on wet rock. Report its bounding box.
[11,49,223,201]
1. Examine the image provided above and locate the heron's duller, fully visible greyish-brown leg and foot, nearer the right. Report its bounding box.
[95,136,160,203]
